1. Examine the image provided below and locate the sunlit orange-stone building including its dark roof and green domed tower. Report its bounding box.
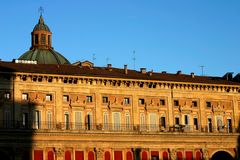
[0,16,240,160]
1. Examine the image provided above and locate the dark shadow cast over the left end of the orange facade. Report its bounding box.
[0,66,35,160]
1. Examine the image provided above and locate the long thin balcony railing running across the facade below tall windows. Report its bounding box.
[0,121,237,133]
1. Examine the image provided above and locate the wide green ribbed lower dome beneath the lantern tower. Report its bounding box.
[18,49,70,64]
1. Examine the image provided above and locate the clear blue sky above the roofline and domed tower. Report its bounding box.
[0,0,240,76]
